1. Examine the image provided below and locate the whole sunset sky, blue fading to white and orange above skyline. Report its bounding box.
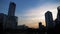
[0,0,60,28]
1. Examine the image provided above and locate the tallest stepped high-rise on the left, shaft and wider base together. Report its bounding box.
[6,2,18,29]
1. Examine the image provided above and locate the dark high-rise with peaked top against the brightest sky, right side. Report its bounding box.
[45,11,53,28]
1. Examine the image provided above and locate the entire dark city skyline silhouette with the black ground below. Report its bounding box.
[0,2,60,34]
